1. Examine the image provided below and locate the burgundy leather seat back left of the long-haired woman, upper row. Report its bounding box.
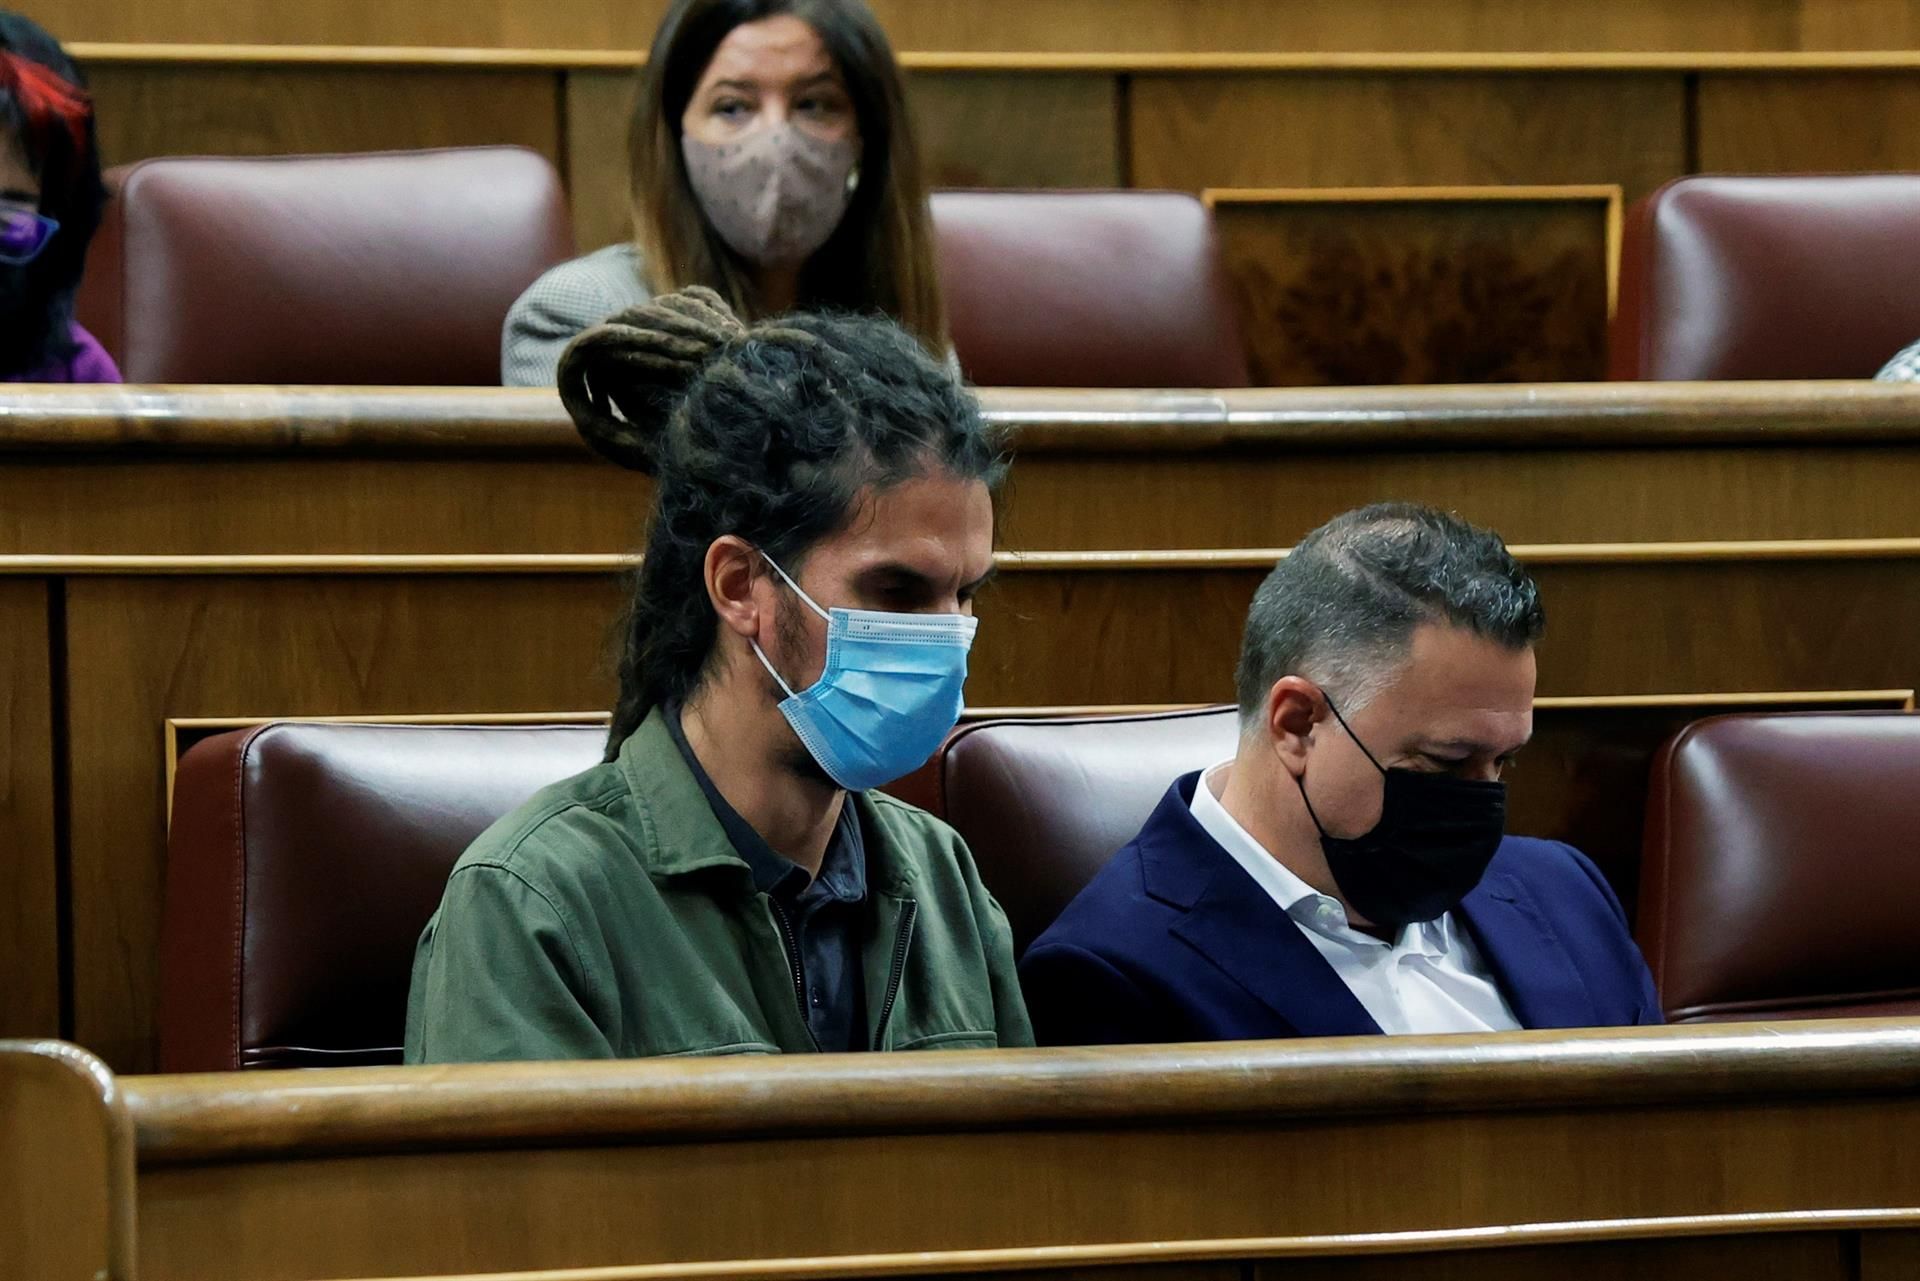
[79,146,572,386]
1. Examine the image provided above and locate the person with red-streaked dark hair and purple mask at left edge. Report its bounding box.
[0,12,119,382]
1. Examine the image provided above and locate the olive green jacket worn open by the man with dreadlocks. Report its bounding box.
[407,711,1033,1064]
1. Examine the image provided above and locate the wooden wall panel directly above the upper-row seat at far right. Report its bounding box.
[1699,71,1920,173]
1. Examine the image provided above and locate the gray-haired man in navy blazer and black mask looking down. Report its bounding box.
[1021,503,1661,1045]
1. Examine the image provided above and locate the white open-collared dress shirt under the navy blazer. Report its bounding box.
[1192,762,1521,1035]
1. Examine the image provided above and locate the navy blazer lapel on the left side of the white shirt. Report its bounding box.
[1140,774,1380,1039]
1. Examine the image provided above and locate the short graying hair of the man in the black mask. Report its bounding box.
[1236,503,1546,726]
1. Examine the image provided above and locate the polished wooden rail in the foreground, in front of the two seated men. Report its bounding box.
[121,1020,1920,1166]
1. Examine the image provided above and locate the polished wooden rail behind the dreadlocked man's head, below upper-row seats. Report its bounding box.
[11,382,1920,459]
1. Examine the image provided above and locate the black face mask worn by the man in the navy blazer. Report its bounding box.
[1294,699,1507,930]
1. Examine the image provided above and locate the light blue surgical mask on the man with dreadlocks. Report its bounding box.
[753,557,979,791]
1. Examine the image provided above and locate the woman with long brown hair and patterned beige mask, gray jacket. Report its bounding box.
[501,0,947,386]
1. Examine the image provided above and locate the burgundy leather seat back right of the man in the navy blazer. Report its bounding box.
[1640,713,1920,1020]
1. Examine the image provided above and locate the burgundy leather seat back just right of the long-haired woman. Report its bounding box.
[933,192,1248,388]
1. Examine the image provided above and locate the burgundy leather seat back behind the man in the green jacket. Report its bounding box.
[159,724,607,1072]
